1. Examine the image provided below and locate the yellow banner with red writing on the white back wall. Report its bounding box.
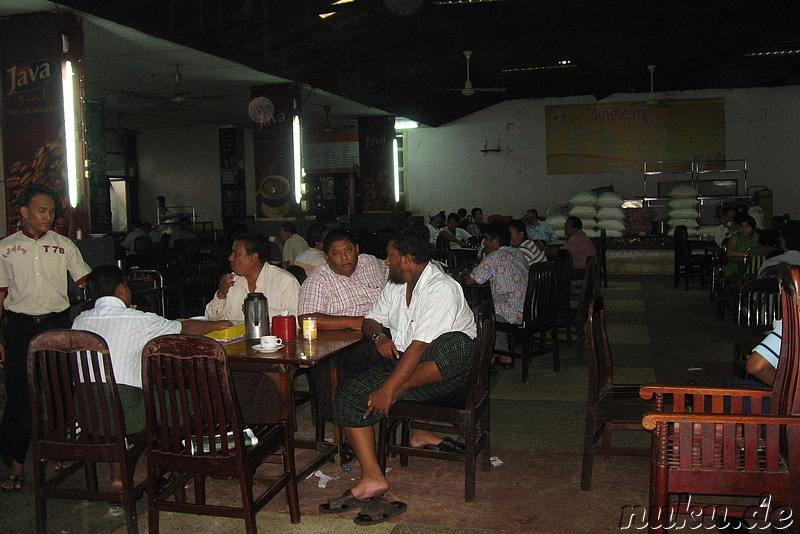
[545,98,725,174]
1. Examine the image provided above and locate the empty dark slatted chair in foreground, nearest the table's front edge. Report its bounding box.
[142,335,300,534]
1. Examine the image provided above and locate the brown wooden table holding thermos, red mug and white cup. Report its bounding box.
[222,330,365,480]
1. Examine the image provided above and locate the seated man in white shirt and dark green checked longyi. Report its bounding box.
[321,231,477,521]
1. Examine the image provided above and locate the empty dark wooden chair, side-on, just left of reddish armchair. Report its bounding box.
[581,296,653,491]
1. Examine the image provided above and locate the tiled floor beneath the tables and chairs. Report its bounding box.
[0,276,752,534]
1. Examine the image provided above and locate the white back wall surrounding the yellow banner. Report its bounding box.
[406,86,800,221]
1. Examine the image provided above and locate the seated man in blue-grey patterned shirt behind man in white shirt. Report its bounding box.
[464,220,538,369]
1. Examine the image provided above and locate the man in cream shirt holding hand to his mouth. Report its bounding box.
[206,232,300,323]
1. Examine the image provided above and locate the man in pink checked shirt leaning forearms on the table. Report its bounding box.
[298,230,389,421]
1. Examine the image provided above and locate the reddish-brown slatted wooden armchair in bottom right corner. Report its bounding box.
[640,267,800,533]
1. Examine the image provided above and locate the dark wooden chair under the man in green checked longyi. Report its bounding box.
[378,301,495,502]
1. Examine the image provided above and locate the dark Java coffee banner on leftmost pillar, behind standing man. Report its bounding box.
[0,13,83,233]
